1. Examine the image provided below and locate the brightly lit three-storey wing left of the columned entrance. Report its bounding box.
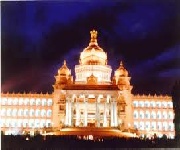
[0,93,53,134]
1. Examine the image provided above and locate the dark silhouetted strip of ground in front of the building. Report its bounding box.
[1,135,179,150]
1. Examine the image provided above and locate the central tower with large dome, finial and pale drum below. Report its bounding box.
[75,30,112,84]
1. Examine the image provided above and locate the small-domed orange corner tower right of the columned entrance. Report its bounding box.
[112,61,133,129]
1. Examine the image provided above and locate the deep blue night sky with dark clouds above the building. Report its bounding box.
[1,0,180,95]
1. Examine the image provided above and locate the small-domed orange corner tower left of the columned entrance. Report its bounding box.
[53,60,73,127]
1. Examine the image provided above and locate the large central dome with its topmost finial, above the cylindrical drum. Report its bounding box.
[80,30,107,65]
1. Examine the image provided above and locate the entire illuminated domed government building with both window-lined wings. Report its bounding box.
[0,30,175,138]
